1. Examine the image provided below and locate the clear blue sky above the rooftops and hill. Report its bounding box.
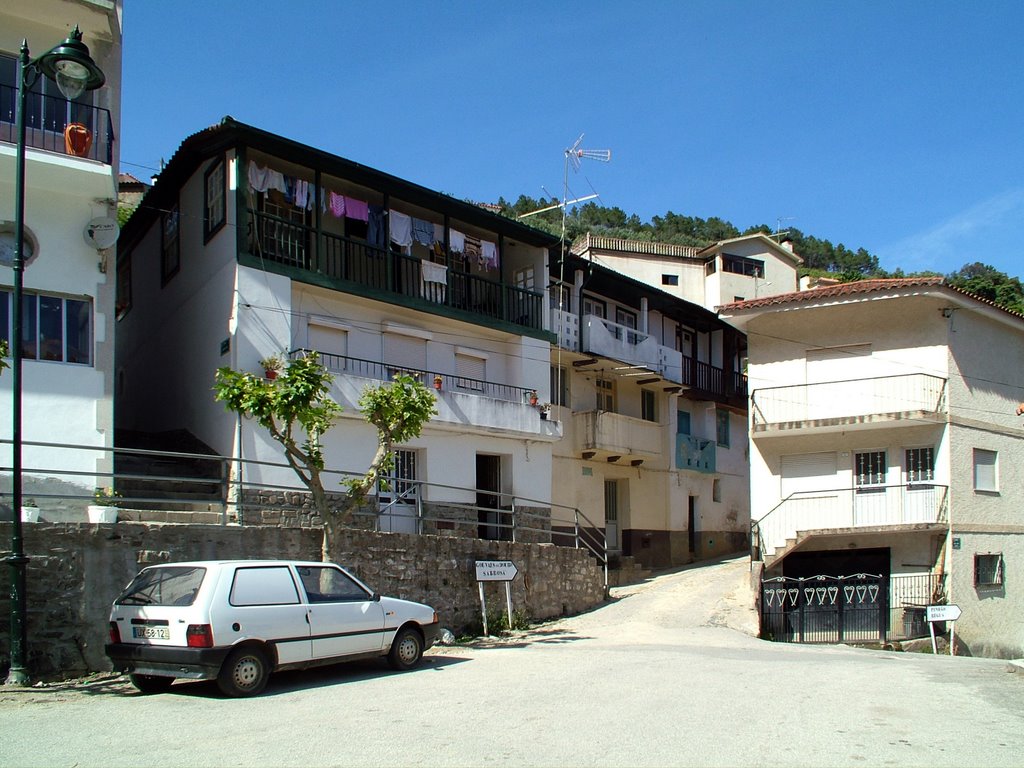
[121,0,1024,275]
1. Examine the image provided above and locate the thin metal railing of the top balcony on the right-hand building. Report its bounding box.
[751,374,946,429]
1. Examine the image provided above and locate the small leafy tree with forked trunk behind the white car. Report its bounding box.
[214,354,436,560]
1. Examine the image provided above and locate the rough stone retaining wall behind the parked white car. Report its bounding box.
[0,522,604,679]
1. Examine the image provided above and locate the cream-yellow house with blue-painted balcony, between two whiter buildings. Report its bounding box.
[550,256,750,568]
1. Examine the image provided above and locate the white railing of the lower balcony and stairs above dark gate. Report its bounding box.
[752,484,946,556]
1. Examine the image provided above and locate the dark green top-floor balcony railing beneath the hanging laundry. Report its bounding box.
[249,209,543,330]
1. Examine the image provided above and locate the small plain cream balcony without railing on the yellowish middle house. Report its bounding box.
[572,411,665,466]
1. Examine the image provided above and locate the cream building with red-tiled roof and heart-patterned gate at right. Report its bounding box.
[721,278,1024,657]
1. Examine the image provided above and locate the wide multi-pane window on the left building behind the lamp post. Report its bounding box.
[0,291,92,366]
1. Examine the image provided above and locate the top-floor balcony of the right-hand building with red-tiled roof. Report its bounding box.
[751,374,946,436]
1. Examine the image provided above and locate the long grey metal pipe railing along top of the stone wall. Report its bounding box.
[0,440,608,584]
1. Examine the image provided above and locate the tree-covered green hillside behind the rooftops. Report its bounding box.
[498,195,1024,314]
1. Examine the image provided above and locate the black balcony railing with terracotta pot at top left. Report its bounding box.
[0,85,114,165]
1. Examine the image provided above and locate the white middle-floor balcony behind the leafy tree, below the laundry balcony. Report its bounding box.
[299,349,562,440]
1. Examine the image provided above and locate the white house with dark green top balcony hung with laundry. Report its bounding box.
[117,118,561,538]
